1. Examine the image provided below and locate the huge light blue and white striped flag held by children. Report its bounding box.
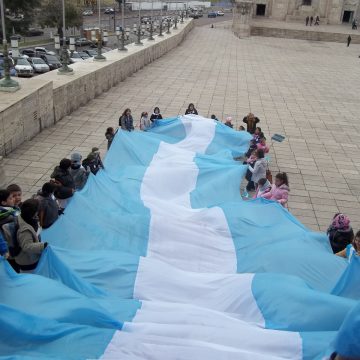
[0,116,360,360]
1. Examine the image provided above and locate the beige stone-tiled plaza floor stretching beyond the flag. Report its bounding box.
[5,21,360,230]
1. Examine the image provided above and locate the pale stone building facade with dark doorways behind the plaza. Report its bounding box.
[252,0,360,24]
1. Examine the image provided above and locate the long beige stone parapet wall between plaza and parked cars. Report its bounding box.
[0,20,194,156]
